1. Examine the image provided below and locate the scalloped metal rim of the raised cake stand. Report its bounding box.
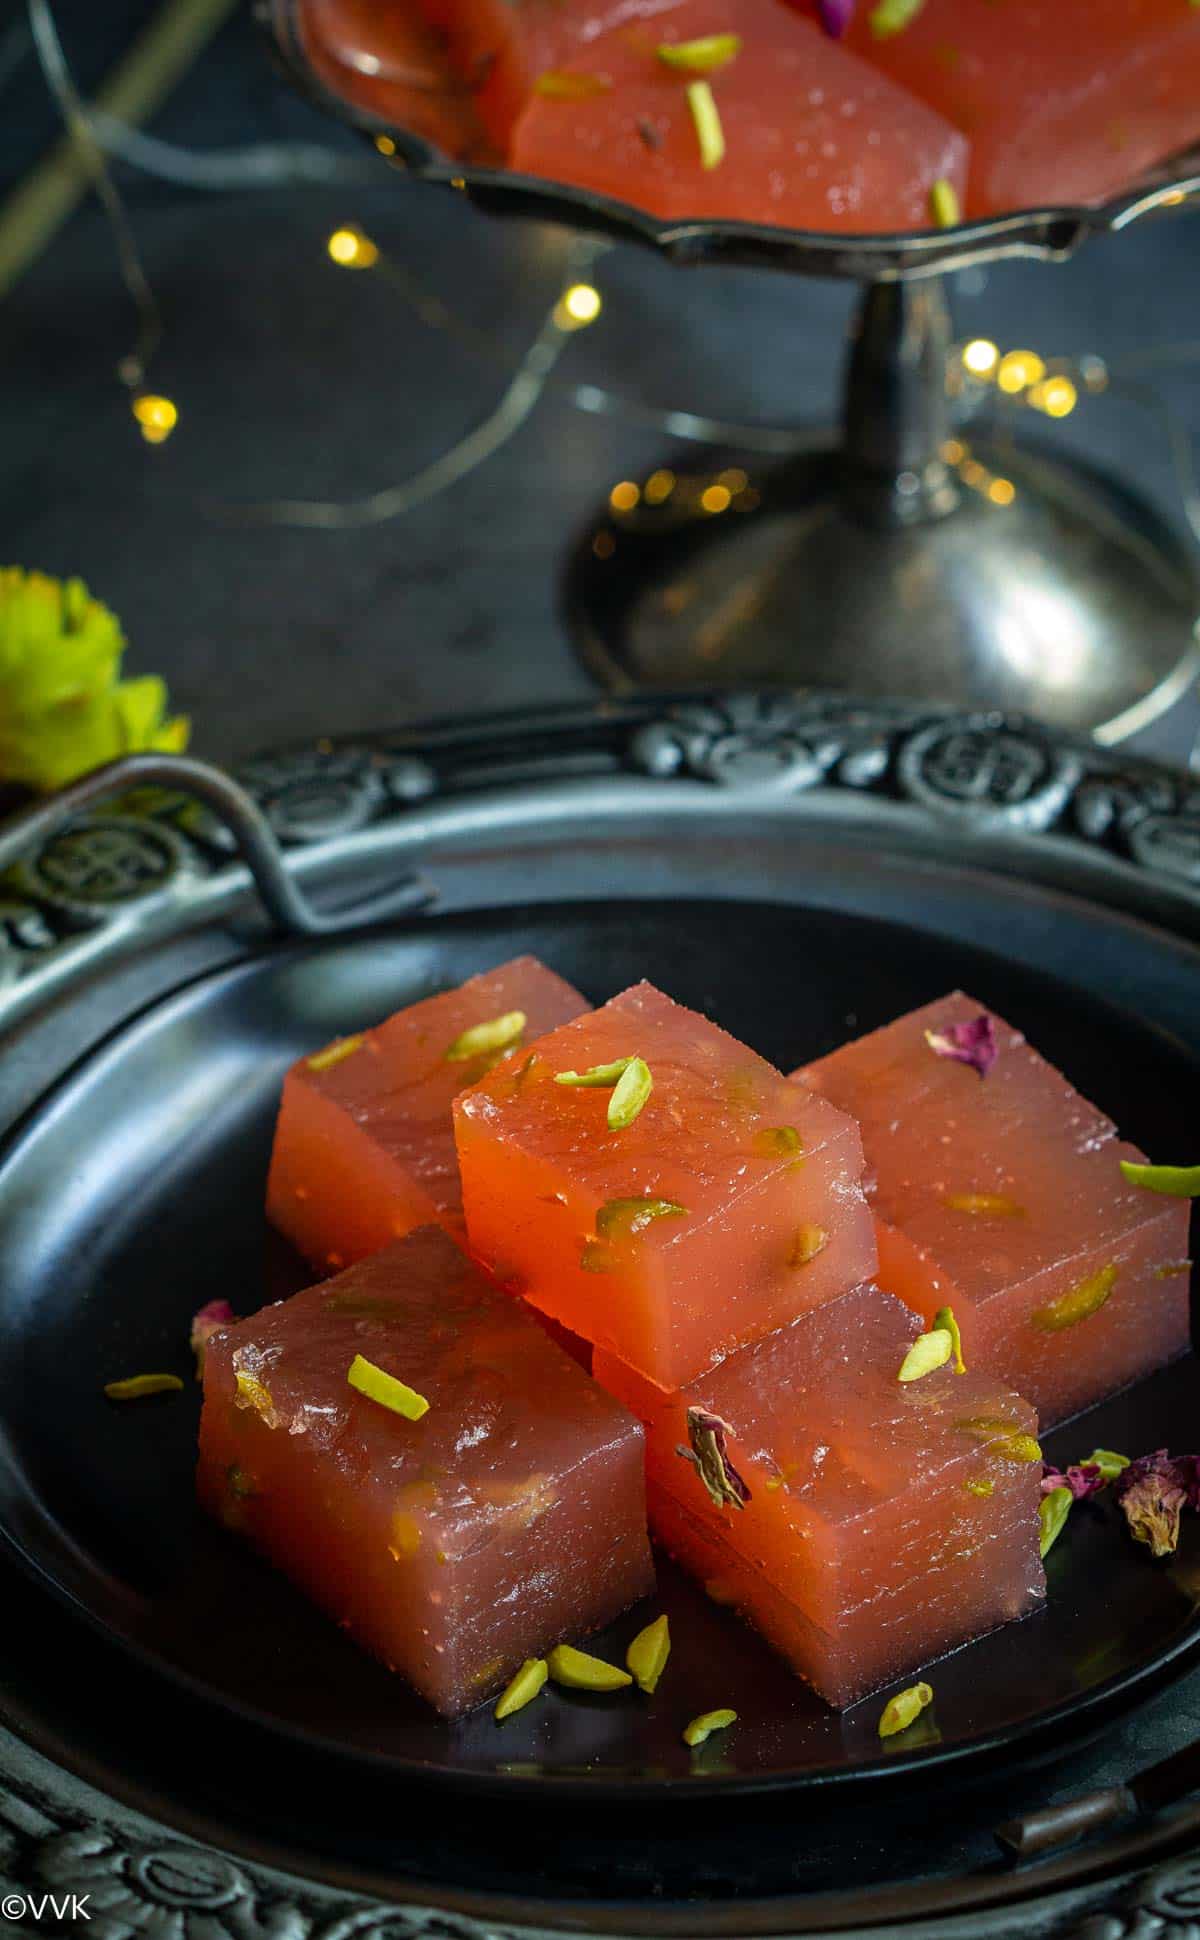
[254,0,1200,281]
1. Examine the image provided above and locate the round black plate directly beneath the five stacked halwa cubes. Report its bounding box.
[0,706,1200,1791]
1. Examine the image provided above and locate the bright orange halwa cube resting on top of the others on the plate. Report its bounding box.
[456,984,874,1387]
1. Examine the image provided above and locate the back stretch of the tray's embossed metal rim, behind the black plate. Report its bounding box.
[0,689,1200,1028]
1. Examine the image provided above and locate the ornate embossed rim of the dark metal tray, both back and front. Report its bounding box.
[0,693,1200,1940]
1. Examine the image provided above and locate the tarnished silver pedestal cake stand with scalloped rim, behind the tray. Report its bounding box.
[267,0,1200,743]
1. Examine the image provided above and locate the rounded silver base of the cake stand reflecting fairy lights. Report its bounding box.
[566,446,1200,743]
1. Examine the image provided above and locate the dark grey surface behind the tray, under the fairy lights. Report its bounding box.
[0,0,1200,760]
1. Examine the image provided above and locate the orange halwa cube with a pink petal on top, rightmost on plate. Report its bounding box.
[795,991,1188,1426]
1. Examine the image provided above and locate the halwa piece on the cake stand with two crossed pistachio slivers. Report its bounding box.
[512,0,967,231]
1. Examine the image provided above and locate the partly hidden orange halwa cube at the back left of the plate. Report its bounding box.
[268,956,587,1273]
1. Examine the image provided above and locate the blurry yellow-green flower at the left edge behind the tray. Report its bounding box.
[0,566,190,790]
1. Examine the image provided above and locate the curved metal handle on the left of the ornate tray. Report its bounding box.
[0,755,434,937]
